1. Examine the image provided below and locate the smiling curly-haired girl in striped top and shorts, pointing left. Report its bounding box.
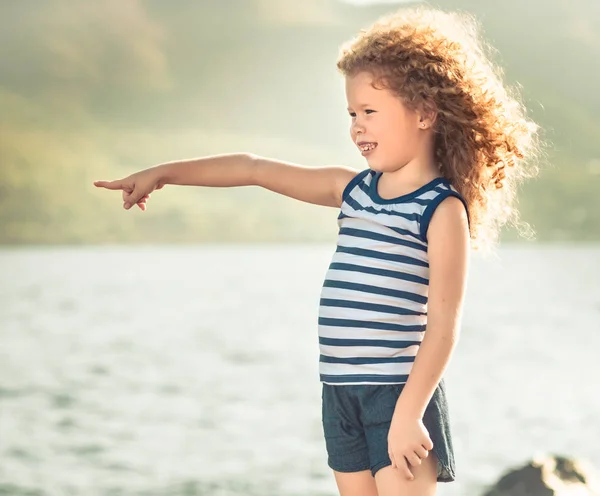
[94,4,536,496]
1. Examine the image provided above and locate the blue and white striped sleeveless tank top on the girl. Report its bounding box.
[319,169,466,385]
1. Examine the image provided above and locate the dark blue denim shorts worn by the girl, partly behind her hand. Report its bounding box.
[322,379,456,482]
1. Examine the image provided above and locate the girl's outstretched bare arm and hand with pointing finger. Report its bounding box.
[94,153,357,210]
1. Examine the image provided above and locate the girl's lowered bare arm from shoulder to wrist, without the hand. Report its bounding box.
[396,196,470,419]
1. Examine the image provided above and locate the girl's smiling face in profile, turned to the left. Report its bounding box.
[346,72,425,172]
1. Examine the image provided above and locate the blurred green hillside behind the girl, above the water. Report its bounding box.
[0,0,600,244]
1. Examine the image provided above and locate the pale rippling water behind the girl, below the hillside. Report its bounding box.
[0,245,600,496]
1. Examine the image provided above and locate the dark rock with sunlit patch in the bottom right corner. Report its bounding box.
[483,455,600,496]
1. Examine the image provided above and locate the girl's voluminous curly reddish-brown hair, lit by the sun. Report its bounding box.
[337,7,539,248]
